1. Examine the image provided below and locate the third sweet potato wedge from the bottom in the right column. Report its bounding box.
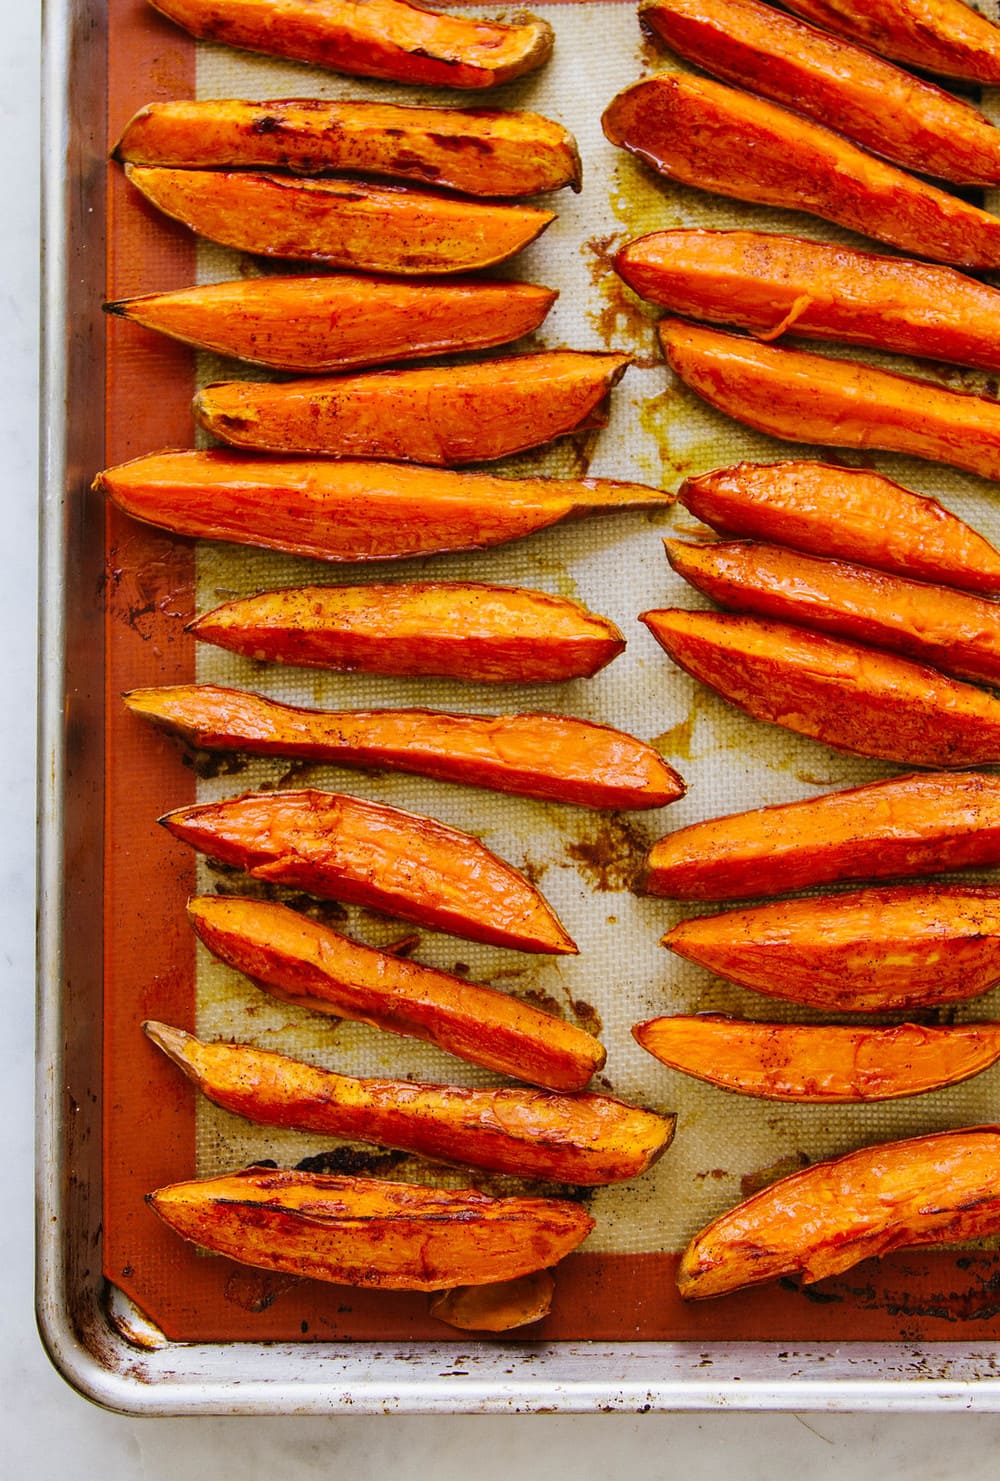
[662,884,1000,1013]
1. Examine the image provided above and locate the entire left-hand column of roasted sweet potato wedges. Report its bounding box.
[113,0,651,1328]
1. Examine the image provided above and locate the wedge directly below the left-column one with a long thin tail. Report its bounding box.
[191,581,625,684]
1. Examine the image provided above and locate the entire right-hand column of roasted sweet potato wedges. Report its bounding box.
[604,0,1000,1297]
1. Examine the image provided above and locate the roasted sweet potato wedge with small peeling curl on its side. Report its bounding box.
[615,231,1000,370]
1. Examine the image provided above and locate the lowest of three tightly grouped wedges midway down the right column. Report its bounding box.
[641,609,1000,767]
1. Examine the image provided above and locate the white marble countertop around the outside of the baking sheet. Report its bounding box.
[9,4,1000,1481]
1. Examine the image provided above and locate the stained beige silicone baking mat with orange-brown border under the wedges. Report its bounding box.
[101,0,1000,1340]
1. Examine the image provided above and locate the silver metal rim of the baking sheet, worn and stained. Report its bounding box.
[36,0,1000,1416]
